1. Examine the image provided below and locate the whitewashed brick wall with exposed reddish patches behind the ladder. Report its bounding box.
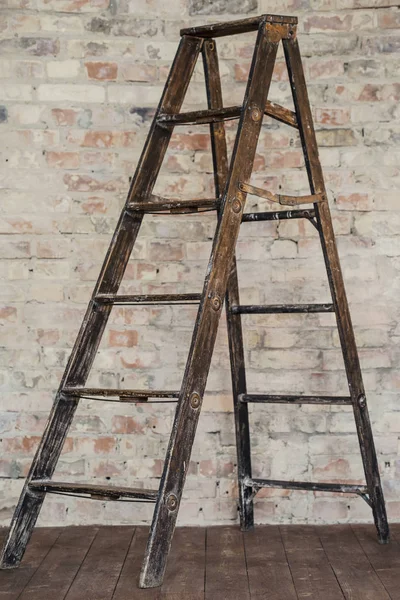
[0,0,400,524]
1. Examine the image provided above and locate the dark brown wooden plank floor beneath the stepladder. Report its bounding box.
[0,524,400,600]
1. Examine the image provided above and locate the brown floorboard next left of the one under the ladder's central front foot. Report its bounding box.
[65,527,134,600]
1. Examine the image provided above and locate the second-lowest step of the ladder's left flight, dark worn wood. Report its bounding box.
[62,387,179,403]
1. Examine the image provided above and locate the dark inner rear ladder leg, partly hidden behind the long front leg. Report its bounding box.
[203,40,254,531]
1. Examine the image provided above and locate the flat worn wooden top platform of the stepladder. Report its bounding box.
[180,15,298,37]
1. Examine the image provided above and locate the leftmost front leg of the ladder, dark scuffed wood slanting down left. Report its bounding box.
[1,37,203,568]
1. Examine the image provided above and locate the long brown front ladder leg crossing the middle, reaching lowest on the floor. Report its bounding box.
[139,21,284,587]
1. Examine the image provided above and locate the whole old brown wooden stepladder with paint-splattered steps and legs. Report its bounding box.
[1,15,389,587]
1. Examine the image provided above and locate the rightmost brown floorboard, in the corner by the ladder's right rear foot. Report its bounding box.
[352,525,400,600]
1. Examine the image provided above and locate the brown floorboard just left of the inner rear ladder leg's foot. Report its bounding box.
[205,527,250,600]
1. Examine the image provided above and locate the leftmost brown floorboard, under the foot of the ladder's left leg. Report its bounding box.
[0,527,61,600]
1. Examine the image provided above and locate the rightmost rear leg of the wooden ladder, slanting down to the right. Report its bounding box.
[283,32,389,543]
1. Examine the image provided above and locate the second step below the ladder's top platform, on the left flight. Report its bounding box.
[127,195,220,214]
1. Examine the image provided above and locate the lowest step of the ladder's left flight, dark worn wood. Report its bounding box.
[29,479,158,502]
